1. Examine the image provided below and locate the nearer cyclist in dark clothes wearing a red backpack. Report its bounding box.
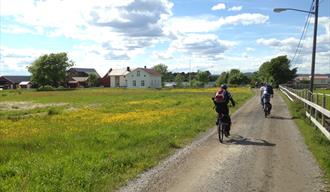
[212,84,235,136]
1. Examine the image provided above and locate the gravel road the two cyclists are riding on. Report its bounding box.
[119,92,329,192]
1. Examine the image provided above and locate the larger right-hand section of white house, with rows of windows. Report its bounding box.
[126,67,162,88]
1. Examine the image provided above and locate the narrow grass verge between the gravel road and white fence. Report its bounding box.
[281,93,330,184]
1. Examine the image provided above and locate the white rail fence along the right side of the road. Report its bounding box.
[280,85,330,140]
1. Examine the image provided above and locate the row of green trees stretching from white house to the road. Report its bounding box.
[154,55,297,87]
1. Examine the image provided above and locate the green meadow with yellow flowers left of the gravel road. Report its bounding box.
[0,88,252,191]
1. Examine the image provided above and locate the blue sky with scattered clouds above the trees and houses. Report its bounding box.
[0,0,330,75]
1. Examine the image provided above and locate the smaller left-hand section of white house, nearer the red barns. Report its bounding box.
[108,67,131,87]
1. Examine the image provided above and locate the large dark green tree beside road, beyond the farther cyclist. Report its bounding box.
[259,55,297,86]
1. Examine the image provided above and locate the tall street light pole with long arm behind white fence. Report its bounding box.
[273,0,319,92]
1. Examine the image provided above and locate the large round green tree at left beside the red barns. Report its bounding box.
[28,53,74,87]
